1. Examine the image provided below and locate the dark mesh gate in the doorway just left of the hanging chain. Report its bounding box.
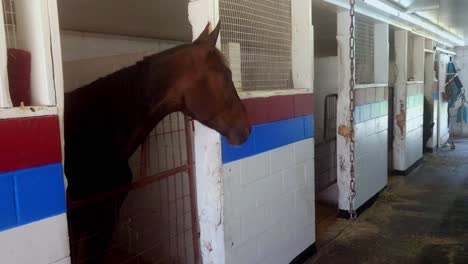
[315,94,338,193]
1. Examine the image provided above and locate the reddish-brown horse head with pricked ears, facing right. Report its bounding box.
[175,24,251,145]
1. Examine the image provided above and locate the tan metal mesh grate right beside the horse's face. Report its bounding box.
[219,0,292,89]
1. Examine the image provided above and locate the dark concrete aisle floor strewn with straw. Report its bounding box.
[306,140,468,264]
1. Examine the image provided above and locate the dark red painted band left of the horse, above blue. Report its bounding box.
[0,116,62,173]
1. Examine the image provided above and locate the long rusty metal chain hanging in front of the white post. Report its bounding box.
[349,0,357,220]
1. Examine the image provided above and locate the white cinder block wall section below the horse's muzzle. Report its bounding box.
[223,139,315,264]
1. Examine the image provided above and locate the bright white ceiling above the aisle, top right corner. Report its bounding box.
[388,0,468,43]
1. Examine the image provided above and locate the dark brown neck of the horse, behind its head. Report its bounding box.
[65,59,176,158]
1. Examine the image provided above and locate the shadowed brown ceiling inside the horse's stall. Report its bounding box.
[57,0,192,41]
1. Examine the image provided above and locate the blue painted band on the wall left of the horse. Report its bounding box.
[0,164,66,231]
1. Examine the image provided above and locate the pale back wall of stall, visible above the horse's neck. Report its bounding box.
[61,31,182,92]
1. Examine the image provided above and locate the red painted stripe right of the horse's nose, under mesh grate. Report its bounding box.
[243,94,314,125]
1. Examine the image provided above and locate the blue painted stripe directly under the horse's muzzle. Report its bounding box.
[221,115,314,163]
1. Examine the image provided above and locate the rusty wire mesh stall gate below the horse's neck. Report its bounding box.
[69,113,199,264]
